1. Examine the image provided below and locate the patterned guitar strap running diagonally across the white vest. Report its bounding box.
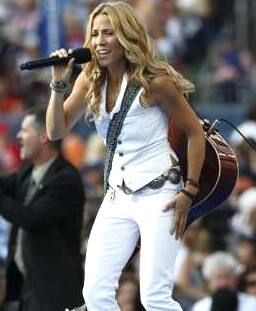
[104,83,141,193]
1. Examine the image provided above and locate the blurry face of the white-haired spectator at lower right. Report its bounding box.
[209,269,237,292]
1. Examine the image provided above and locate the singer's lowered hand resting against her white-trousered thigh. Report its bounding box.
[163,192,192,240]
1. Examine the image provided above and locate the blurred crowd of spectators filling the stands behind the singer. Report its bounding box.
[0,0,256,311]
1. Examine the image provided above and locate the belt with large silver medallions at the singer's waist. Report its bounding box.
[118,168,182,194]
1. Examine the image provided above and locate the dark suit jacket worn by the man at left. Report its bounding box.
[0,156,84,311]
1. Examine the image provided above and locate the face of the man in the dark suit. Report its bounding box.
[17,115,42,160]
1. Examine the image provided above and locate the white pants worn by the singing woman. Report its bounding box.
[84,182,182,311]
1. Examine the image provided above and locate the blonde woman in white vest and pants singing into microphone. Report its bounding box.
[46,2,205,311]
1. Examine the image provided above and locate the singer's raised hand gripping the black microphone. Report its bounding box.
[50,49,75,84]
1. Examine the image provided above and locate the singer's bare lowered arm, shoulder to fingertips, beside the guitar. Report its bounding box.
[150,75,205,238]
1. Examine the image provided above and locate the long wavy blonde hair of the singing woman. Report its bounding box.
[83,2,194,116]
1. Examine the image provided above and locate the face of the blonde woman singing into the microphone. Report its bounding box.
[91,14,126,70]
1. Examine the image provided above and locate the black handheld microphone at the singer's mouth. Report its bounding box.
[20,48,92,70]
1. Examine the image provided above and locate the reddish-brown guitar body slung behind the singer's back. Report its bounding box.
[168,120,238,226]
